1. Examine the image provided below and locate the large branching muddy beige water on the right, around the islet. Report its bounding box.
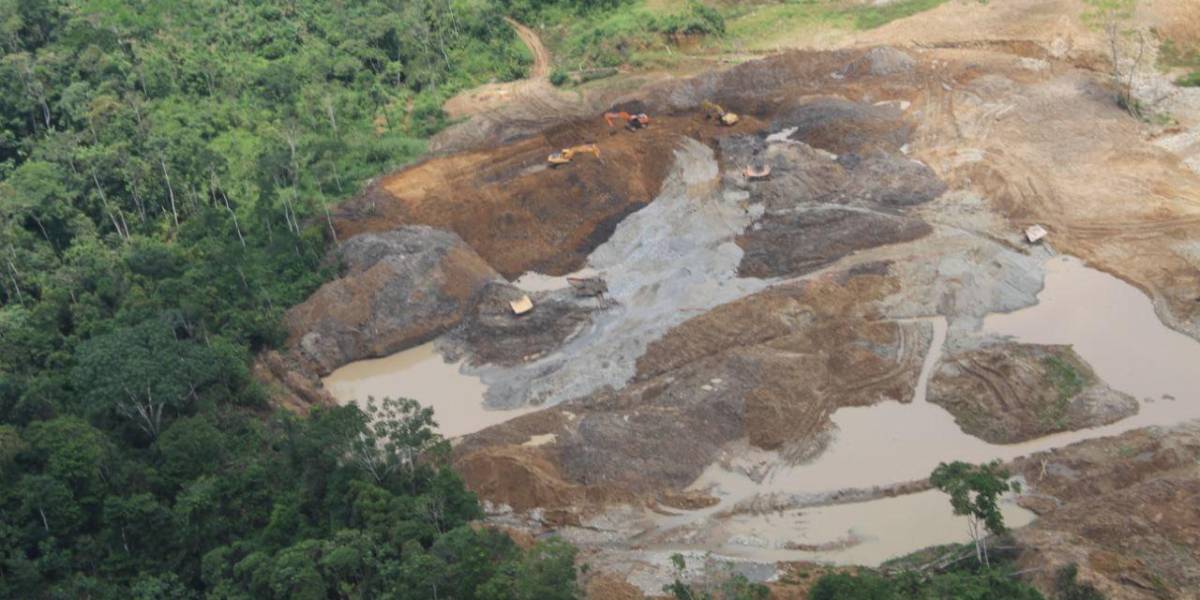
[655,257,1200,565]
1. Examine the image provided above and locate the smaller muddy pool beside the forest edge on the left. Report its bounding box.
[323,342,534,438]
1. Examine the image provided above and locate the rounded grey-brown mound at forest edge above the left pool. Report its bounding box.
[284,227,497,376]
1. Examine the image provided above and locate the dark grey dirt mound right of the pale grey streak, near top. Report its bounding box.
[721,123,946,277]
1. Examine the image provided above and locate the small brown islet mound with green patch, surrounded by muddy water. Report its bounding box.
[929,343,1138,444]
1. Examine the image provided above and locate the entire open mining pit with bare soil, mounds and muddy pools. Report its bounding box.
[259,27,1200,598]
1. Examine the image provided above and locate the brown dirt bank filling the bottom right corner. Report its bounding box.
[1016,424,1200,600]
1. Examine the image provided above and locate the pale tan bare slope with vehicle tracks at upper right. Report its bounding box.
[917,50,1200,335]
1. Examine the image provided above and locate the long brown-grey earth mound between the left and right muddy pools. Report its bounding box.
[456,267,929,510]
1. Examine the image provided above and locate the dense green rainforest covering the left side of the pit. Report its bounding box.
[0,0,604,599]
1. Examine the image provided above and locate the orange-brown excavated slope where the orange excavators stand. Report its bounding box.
[335,122,679,278]
